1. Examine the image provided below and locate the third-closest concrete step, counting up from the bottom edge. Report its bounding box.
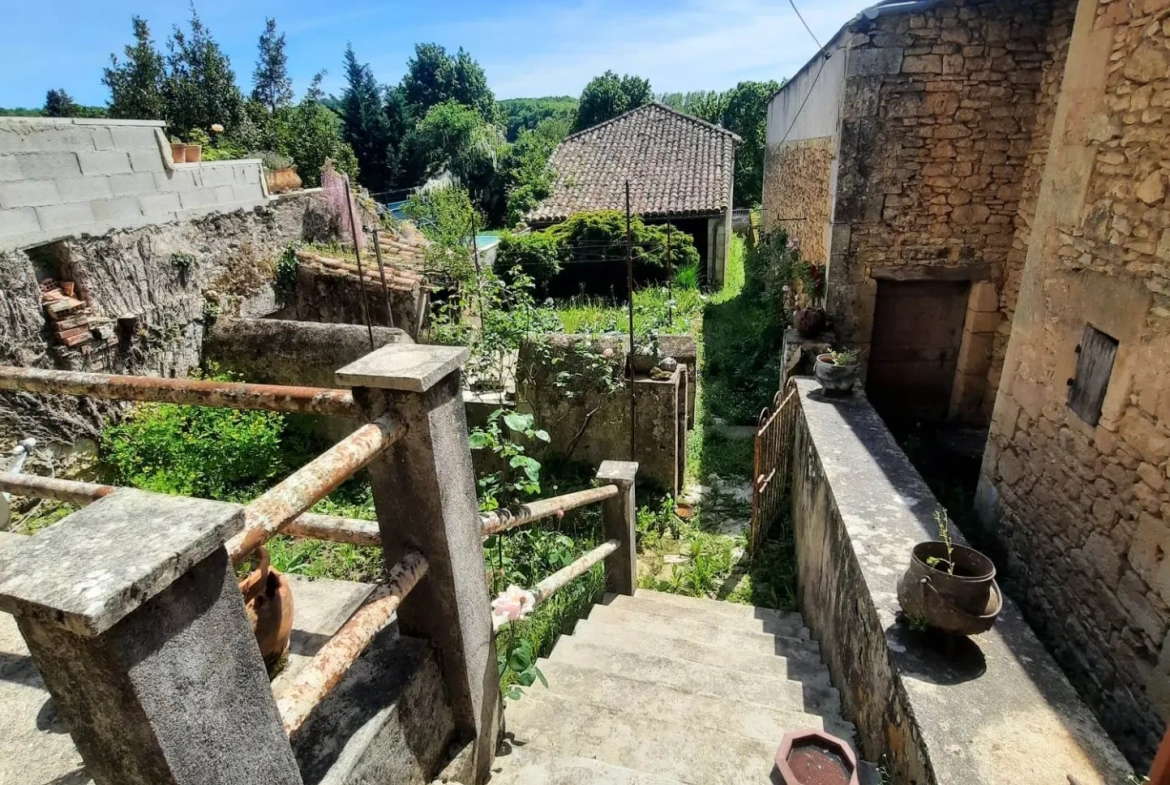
[549,635,841,717]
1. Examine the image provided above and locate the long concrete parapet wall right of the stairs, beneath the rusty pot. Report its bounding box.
[792,378,1130,785]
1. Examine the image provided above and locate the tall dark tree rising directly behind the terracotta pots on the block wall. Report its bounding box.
[166,6,248,140]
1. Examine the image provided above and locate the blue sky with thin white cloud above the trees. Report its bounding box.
[0,0,873,106]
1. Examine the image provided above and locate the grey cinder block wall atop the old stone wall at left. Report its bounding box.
[0,117,268,249]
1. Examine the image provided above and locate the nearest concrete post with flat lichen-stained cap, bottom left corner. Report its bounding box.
[0,489,302,785]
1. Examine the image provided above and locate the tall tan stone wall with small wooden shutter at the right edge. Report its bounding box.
[978,0,1170,765]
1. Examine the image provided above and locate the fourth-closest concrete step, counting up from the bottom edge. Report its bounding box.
[562,619,830,687]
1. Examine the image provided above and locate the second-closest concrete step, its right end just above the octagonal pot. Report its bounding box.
[538,660,854,744]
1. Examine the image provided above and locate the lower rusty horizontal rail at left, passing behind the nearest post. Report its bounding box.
[0,473,381,552]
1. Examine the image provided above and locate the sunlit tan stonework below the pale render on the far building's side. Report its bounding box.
[763,137,835,264]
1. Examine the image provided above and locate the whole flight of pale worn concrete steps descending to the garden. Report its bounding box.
[491,590,876,785]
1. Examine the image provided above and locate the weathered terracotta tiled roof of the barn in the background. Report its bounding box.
[528,103,739,222]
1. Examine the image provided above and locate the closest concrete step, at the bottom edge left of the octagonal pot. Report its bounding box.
[508,690,778,785]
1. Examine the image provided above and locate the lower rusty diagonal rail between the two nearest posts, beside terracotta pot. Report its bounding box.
[275,551,427,735]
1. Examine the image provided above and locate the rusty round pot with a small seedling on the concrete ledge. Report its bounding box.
[897,510,1004,635]
